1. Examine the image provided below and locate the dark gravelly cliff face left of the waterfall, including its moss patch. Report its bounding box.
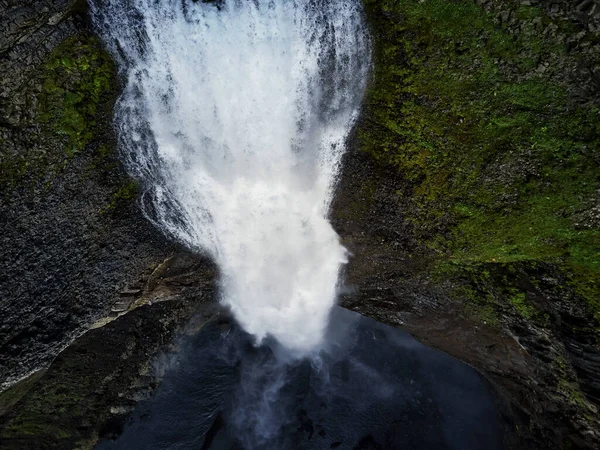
[0,1,183,386]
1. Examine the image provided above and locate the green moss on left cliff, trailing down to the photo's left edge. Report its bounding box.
[0,33,116,191]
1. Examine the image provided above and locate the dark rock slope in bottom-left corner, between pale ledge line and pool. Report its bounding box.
[0,296,214,450]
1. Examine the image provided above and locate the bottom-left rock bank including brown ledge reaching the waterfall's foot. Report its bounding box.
[0,253,218,450]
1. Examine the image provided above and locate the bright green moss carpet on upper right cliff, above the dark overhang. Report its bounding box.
[358,0,600,313]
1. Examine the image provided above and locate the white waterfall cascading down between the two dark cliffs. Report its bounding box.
[92,0,370,355]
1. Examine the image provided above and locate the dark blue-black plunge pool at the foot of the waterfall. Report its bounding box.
[97,308,504,450]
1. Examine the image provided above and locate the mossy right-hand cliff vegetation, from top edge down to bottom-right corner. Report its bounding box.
[357,0,600,440]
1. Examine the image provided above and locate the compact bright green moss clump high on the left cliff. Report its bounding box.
[39,35,115,156]
